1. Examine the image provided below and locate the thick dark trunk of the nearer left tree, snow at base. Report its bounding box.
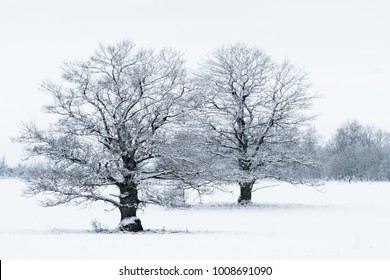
[118,180,143,232]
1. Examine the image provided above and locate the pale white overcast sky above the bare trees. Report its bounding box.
[0,0,390,164]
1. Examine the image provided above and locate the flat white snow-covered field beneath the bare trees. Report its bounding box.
[0,179,390,259]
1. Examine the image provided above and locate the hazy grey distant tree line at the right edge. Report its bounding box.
[284,120,390,181]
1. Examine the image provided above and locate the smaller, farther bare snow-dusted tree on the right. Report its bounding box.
[198,44,314,203]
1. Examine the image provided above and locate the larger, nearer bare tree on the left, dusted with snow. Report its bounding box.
[17,41,195,231]
